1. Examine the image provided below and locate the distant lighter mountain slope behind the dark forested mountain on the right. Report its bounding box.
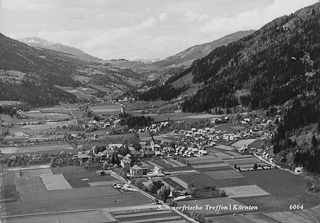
[154,30,254,67]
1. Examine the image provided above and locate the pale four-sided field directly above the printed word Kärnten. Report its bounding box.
[220,185,270,198]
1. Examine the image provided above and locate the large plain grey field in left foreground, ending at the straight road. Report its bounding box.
[1,186,152,216]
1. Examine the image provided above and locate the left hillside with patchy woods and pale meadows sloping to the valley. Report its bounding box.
[0,34,145,106]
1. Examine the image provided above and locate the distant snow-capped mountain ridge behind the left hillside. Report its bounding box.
[19,37,101,61]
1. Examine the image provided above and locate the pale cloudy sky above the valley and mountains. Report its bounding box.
[0,0,318,59]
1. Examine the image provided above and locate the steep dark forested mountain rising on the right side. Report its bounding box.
[141,3,320,113]
